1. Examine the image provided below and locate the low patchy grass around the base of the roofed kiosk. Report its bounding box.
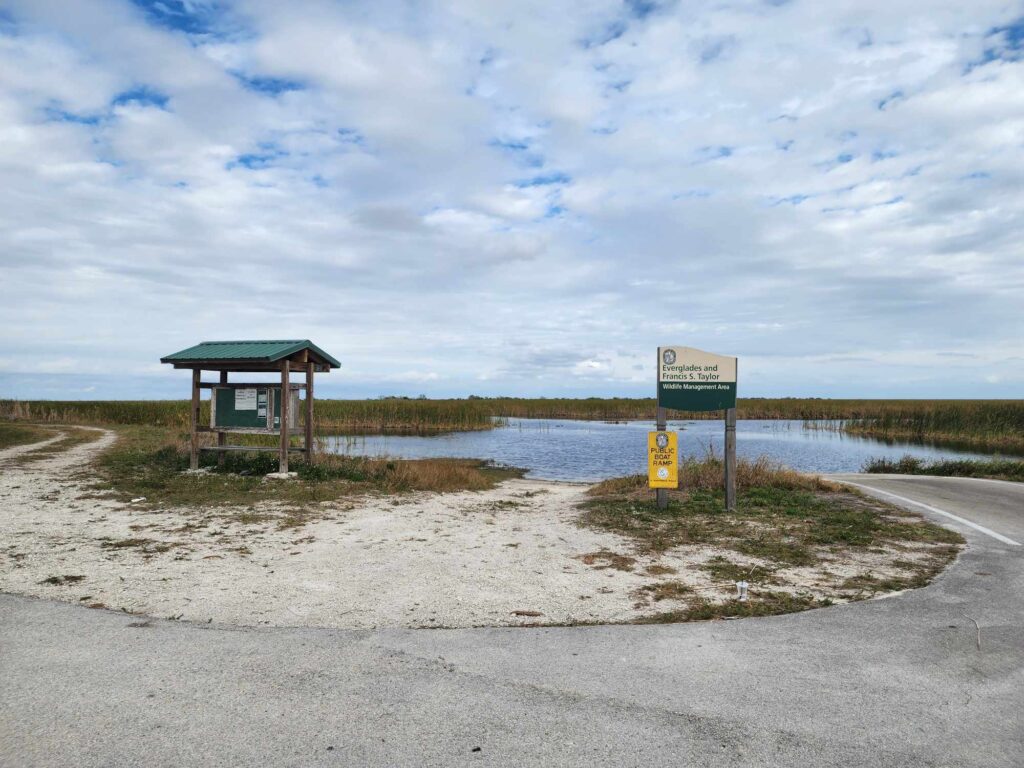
[96,427,521,512]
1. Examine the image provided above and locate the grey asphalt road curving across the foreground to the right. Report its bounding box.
[0,476,1024,768]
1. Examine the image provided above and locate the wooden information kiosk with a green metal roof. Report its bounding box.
[160,339,341,473]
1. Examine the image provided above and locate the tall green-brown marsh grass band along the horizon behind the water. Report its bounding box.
[0,397,1024,453]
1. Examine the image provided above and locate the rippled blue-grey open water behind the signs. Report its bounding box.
[329,419,999,482]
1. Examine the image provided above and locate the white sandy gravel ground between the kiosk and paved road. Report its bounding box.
[0,430,954,628]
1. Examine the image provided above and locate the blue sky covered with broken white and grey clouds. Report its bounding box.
[0,0,1024,399]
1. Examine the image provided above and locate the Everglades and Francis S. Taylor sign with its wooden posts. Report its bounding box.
[651,347,737,510]
